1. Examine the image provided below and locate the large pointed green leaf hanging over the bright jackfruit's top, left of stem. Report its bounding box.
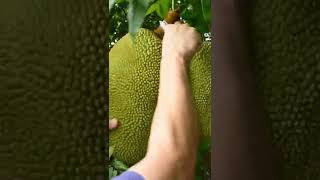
[128,0,148,40]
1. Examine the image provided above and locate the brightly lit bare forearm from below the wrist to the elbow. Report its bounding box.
[147,56,198,179]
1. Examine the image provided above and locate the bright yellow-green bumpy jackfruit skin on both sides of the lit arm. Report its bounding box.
[109,28,211,164]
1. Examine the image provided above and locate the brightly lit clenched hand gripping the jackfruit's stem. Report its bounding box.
[162,21,201,62]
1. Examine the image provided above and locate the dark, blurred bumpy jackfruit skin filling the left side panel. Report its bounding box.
[0,0,108,180]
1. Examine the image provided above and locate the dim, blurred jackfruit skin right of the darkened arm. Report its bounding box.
[250,0,320,180]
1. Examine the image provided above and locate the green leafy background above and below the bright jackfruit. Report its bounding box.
[108,0,211,180]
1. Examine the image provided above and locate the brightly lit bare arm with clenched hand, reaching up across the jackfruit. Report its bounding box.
[131,24,200,180]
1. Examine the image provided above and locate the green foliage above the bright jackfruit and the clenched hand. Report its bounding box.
[109,0,211,48]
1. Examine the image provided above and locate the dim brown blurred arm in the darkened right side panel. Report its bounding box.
[212,0,276,180]
